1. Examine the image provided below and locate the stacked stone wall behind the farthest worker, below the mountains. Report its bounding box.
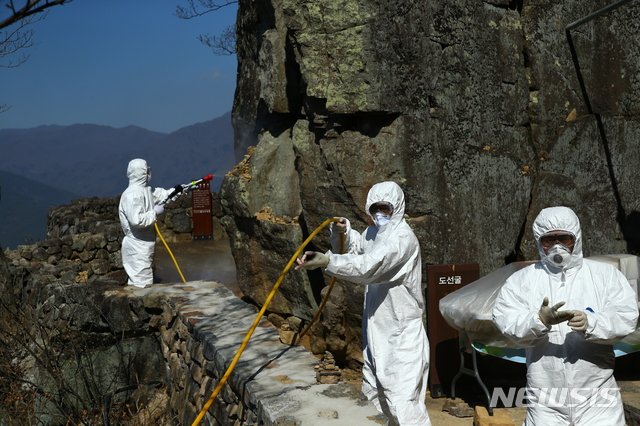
[5,193,224,285]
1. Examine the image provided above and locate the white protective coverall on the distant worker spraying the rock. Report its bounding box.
[118,158,171,287]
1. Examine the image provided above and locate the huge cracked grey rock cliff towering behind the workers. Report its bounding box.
[221,0,640,366]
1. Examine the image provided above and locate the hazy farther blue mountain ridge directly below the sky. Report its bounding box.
[0,112,235,197]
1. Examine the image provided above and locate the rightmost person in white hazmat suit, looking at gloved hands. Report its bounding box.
[493,207,638,426]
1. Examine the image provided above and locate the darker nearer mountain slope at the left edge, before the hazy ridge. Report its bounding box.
[0,171,80,250]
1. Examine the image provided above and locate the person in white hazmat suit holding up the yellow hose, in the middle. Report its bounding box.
[296,182,431,426]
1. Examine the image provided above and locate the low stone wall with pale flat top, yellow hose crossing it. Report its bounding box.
[132,281,387,426]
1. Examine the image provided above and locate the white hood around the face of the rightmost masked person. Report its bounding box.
[533,206,583,273]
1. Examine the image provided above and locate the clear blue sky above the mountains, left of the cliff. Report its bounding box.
[0,0,237,133]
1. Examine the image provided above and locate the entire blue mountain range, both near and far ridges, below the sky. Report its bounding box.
[0,112,235,249]
